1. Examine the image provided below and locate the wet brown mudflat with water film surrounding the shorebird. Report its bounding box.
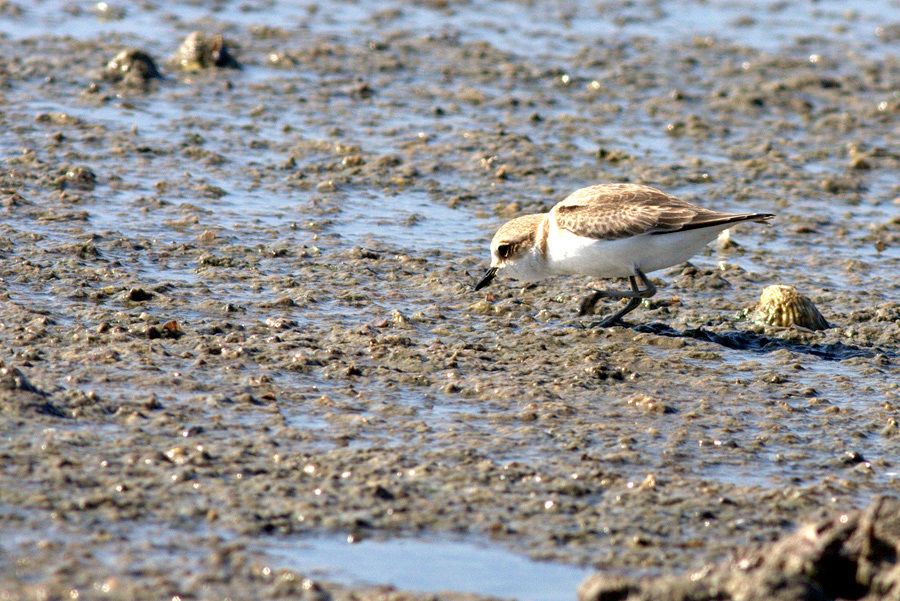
[0,2,900,600]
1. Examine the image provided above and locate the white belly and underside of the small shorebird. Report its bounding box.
[547,225,728,278]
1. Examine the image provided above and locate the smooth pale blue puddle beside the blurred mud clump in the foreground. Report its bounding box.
[266,538,593,601]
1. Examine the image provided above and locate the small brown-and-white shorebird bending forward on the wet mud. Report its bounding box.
[475,184,774,327]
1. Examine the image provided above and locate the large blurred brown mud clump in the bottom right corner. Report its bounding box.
[578,497,900,601]
